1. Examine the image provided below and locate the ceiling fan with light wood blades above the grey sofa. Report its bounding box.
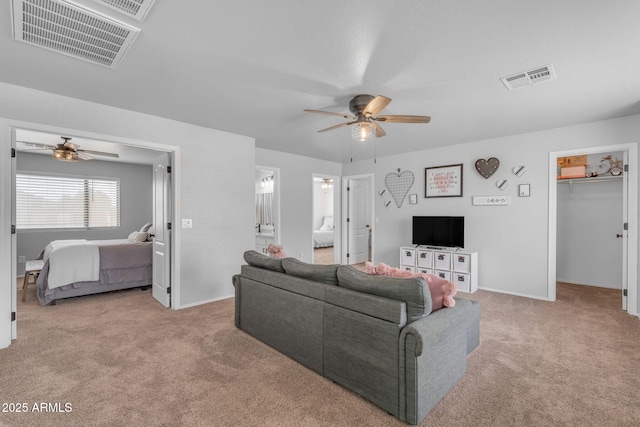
[304,95,431,141]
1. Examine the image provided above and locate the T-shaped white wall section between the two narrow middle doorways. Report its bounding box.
[256,148,342,262]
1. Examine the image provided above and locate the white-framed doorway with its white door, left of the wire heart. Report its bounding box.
[342,174,375,266]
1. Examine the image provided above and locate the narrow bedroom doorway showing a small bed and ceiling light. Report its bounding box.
[312,174,340,265]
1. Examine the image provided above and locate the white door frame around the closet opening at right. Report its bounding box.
[547,142,640,317]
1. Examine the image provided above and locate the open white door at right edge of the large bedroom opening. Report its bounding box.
[152,153,171,307]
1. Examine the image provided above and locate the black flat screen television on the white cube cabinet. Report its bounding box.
[412,216,464,248]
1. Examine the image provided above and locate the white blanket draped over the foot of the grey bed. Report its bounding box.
[43,240,100,289]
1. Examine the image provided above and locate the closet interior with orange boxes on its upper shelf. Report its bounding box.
[556,152,624,289]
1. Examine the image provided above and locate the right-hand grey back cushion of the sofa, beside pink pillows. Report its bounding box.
[337,265,432,322]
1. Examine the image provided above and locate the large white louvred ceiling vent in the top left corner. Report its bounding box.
[12,0,139,68]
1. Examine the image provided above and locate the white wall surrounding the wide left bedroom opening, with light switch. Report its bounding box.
[0,83,255,348]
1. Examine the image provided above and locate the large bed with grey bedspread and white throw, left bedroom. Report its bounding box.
[36,239,153,305]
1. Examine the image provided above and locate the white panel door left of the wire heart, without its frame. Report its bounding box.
[347,178,372,264]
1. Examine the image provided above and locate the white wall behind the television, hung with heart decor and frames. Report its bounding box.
[343,115,640,299]
